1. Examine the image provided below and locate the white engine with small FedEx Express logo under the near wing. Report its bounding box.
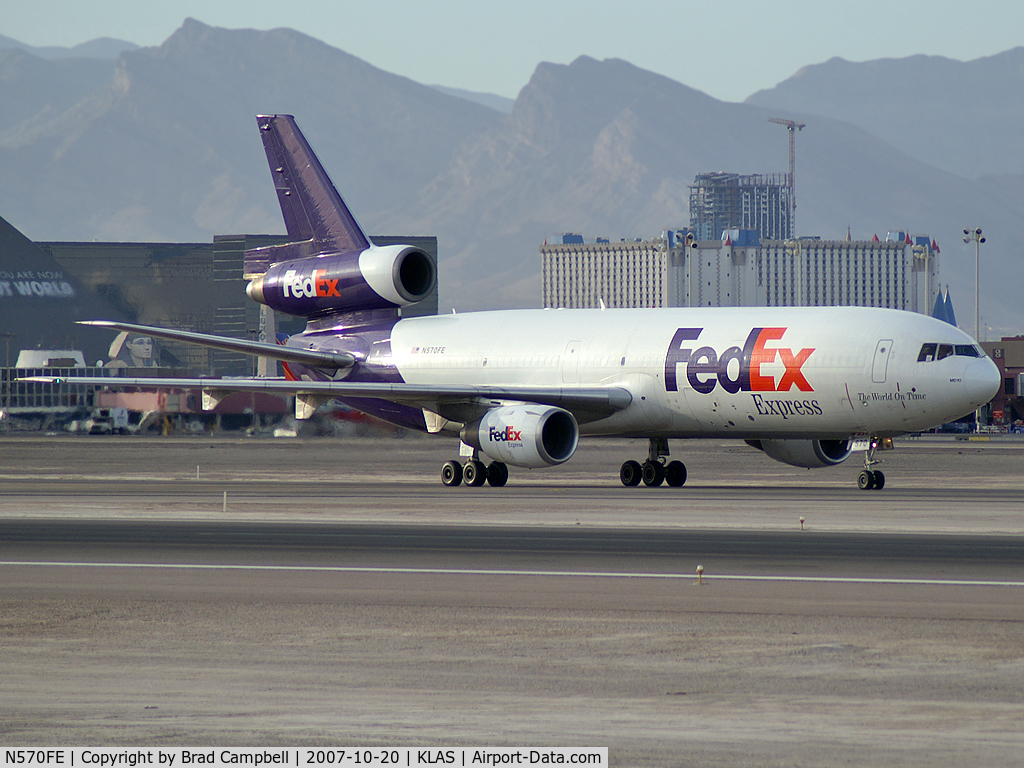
[462,406,580,469]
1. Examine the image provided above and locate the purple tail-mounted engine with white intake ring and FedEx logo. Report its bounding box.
[246,246,436,317]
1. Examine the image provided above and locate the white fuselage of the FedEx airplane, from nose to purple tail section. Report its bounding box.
[389,307,999,439]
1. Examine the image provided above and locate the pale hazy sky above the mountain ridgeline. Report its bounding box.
[8,0,1024,101]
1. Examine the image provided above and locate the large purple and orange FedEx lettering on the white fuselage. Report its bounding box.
[665,328,814,394]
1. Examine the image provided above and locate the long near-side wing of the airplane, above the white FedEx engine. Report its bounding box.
[18,376,633,422]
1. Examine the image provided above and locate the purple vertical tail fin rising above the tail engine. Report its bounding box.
[256,115,370,253]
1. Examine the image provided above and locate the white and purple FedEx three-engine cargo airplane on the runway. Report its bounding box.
[28,115,999,489]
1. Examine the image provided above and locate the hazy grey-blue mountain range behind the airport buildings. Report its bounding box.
[0,19,1024,335]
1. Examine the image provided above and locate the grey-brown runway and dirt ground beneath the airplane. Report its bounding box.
[0,437,1024,766]
